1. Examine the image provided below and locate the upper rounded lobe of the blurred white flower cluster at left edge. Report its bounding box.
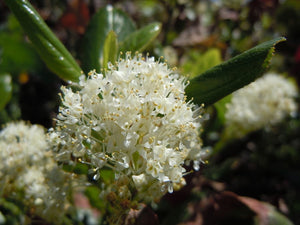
[0,122,49,181]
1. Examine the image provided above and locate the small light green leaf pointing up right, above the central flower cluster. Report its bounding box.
[120,23,161,52]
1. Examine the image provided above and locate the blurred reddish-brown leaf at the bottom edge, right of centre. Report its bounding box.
[183,191,292,225]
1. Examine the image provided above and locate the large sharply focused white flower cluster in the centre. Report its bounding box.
[50,53,202,200]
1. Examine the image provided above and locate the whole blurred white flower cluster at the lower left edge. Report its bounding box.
[0,122,68,224]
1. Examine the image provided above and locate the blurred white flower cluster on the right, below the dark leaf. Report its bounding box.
[225,73,297,137]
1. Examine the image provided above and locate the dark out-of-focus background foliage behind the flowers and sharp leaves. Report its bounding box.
[0,0,300,224]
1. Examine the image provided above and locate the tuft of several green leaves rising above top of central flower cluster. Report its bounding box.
[81,6,161,73]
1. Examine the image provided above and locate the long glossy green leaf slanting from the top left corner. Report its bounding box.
[5,0,81,81]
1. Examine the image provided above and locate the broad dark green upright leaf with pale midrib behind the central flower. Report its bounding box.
[81,6,135,73]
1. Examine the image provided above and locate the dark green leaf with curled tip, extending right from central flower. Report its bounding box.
[186,37,285,105]
